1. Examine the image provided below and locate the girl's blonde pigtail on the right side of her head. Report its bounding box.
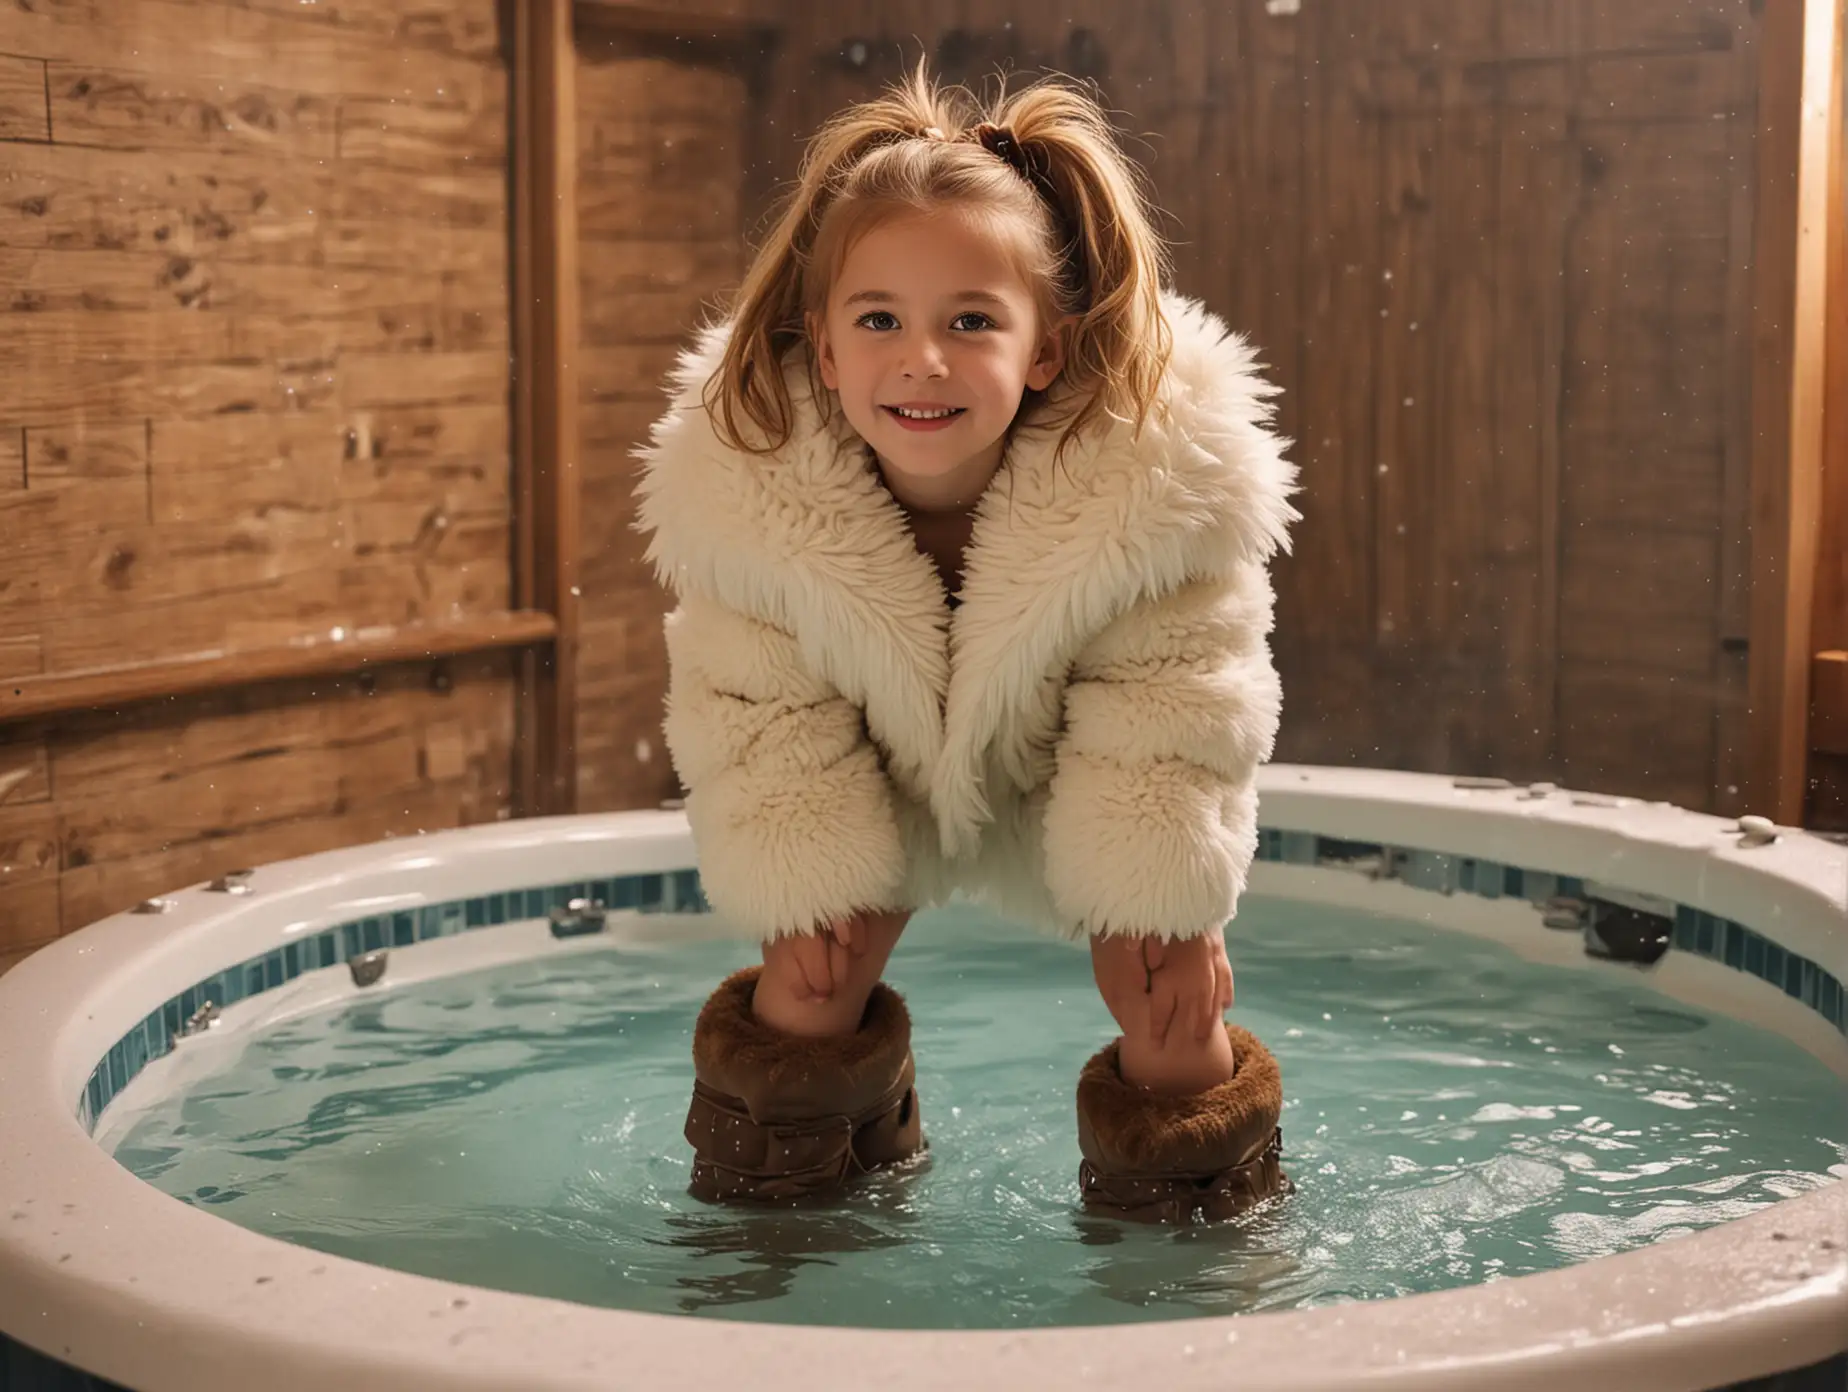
[978,81,1173,449]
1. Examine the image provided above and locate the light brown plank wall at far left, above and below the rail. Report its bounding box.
[0,0,512,967]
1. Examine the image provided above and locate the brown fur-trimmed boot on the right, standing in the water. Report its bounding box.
[1077,1024,1292,1224]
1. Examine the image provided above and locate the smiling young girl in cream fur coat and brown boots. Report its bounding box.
[639,67,1295,1222]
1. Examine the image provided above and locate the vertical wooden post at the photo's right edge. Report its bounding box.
[1746,0,1837,824]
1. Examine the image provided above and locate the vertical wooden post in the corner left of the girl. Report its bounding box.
[510,0,578,817]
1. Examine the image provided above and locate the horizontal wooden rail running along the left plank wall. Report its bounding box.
[0,610,556,723]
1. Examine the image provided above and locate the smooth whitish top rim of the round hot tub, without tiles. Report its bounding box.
[0,765,1848,1392]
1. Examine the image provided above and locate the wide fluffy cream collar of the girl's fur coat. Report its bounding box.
[638,294,1295,856]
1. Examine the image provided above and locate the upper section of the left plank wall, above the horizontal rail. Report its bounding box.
[0,0,508,671]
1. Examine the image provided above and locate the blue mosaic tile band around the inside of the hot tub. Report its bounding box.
[78,828,1848,1131]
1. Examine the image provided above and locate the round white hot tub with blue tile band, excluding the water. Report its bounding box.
[0,765,1848,1392]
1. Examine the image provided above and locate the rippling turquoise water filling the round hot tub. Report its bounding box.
[116,898,1848,1329]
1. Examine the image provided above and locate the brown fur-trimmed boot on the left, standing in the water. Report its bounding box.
[686,967,924,1202]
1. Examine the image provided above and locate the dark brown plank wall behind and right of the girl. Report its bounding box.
[757,0,1757,808]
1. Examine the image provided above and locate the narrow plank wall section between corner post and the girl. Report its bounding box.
[578,7,761,812]
